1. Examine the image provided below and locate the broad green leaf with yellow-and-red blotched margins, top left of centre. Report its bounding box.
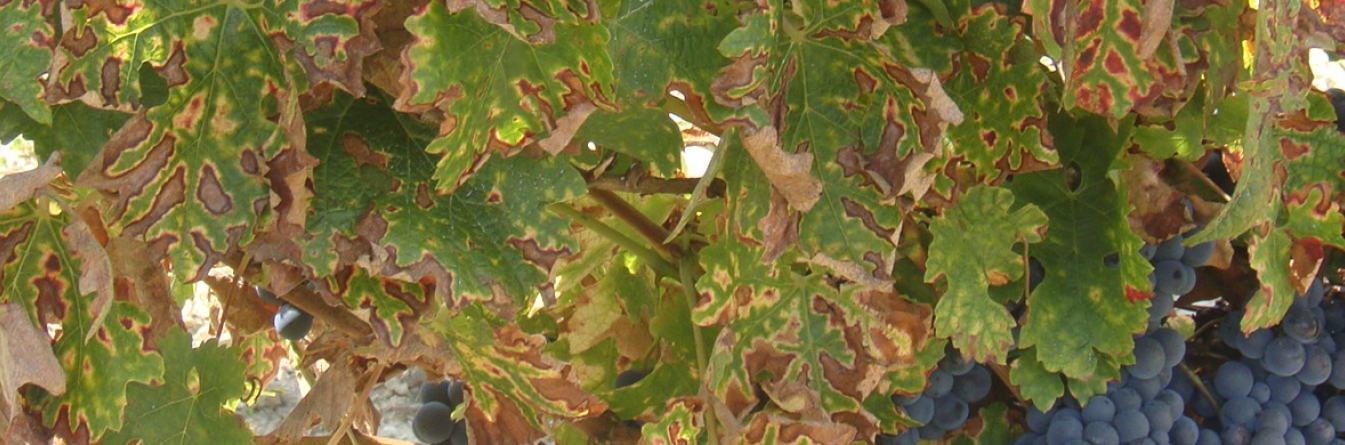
[397,3,612,191]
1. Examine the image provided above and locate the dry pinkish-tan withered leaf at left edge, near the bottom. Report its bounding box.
[0,302,66,424]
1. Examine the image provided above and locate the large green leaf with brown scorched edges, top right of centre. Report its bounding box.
[714,4,962,281]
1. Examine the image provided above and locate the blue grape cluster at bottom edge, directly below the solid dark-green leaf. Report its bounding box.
[1014,328,1200,445]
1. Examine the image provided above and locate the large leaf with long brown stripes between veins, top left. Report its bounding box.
[64,0,297,281]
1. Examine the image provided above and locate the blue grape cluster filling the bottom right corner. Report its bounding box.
[1192,281,1345,445]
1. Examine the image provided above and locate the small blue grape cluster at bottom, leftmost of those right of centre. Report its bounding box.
[874,346,993,445]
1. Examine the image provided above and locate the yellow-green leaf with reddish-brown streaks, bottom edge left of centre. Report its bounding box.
[437,304,607,444]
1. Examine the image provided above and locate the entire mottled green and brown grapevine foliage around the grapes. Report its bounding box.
[0,0,1345,445]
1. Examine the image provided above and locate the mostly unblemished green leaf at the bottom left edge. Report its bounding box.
[101,331,253,445]
